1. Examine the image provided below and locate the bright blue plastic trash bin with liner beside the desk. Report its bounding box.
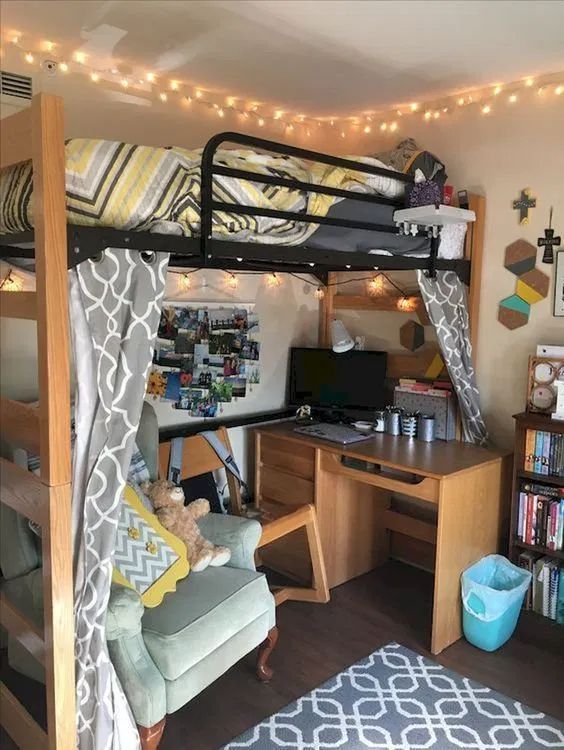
[462,555,532,651]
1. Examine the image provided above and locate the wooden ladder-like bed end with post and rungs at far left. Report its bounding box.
[0,94,76,750]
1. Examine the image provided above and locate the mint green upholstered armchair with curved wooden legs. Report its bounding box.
[0,404,277,750]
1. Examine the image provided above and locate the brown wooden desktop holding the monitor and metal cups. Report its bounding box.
[257,421,508,478]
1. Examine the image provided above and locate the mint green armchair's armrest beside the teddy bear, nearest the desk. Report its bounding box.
[198,513,262,570]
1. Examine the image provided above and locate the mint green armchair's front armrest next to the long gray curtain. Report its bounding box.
[106,584,167,727]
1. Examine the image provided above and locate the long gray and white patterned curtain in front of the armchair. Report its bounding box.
[69,249,168,750]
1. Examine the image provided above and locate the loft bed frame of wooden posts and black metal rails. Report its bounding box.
[0,94,485,750]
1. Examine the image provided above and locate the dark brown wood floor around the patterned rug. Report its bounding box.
[2,562,564,750]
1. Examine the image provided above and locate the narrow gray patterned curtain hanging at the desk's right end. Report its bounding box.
[417,271,488,445]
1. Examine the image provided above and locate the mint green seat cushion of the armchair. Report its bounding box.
[142,567,274,680]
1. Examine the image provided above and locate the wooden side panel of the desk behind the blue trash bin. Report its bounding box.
[431,460,506,654]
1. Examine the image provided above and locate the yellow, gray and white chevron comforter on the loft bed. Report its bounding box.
[0,138,404,245]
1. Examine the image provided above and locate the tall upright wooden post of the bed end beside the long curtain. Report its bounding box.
[31,94,76,750]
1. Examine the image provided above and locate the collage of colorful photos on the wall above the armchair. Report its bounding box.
[147,302,260,417]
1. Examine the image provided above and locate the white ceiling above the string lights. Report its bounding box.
[2,0,564,116]
